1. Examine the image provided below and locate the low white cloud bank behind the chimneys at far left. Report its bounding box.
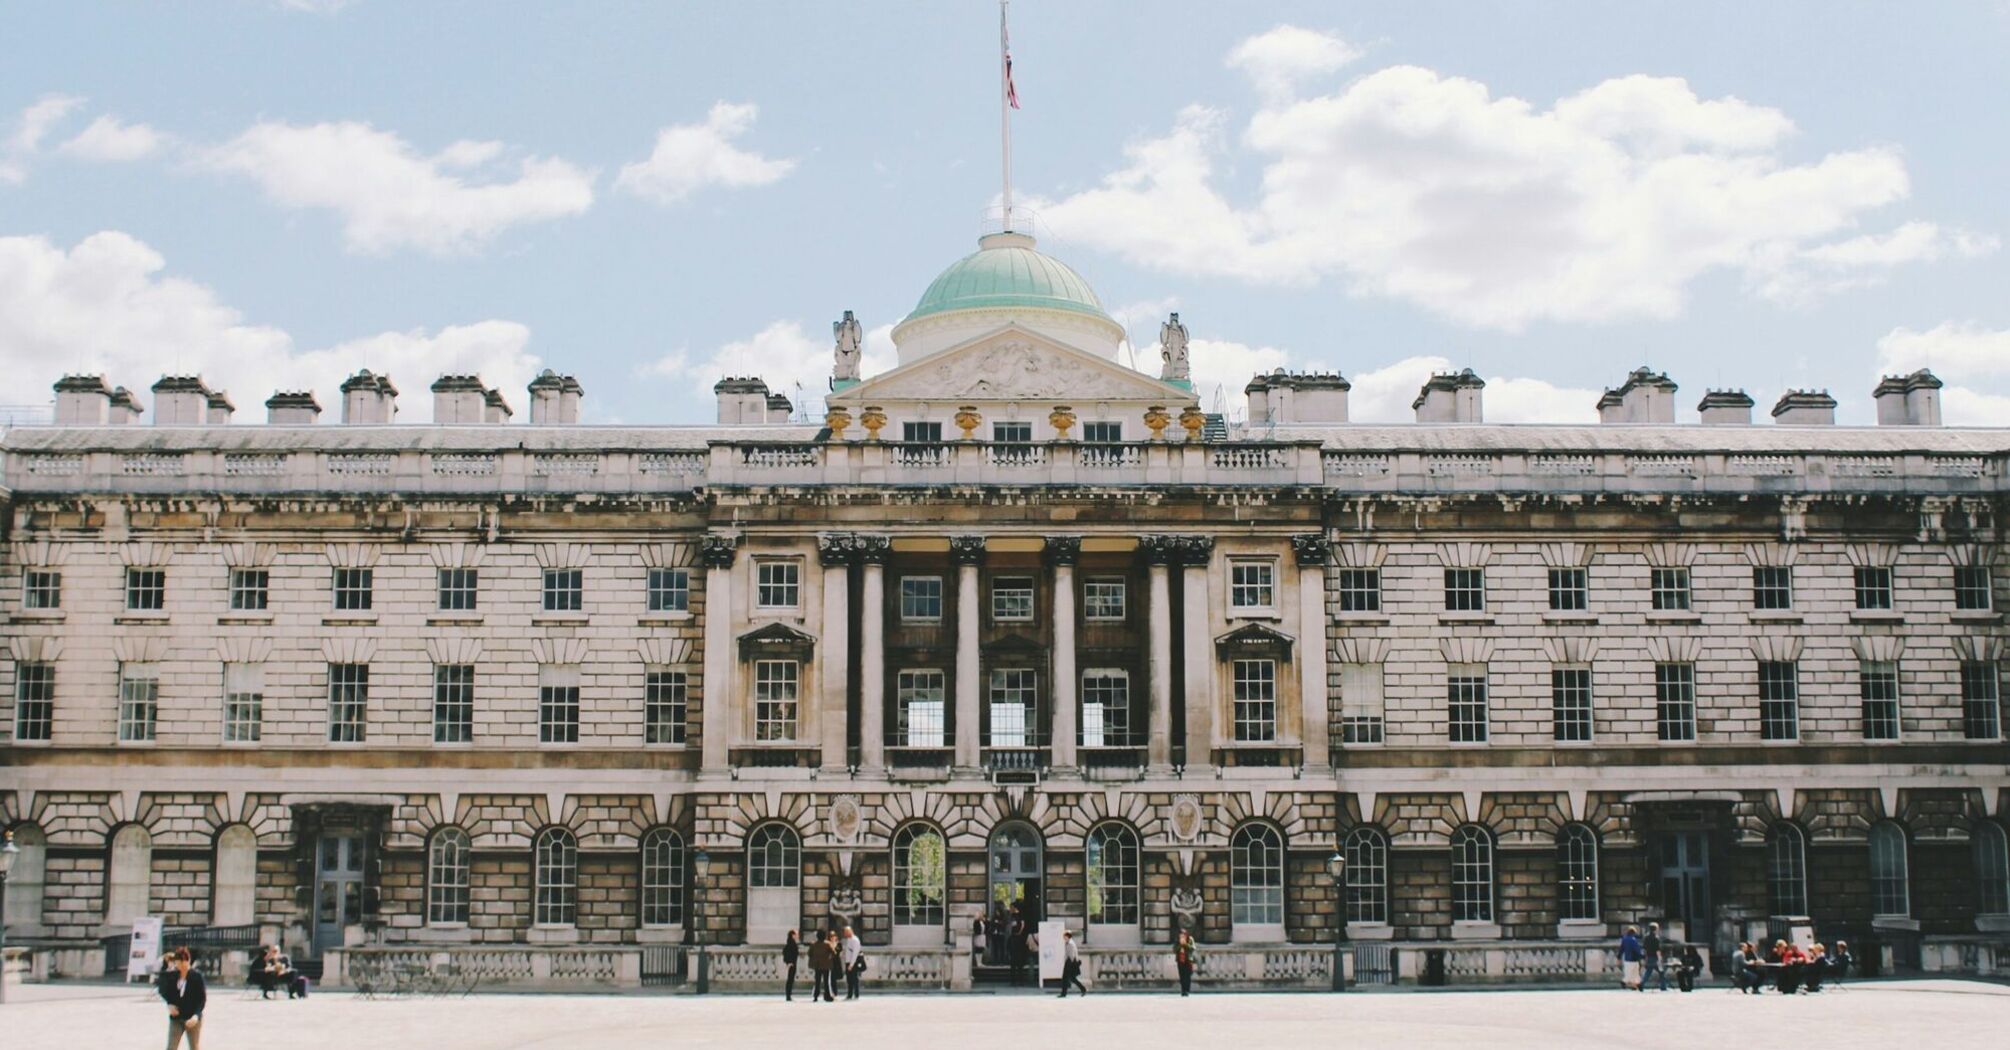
[0,231,541,422]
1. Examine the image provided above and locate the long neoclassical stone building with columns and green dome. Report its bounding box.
[0,233,2010,980]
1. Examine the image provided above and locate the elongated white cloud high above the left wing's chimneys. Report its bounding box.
[205,121,593,253]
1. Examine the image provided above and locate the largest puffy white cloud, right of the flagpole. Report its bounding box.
[1033,48,1945,330]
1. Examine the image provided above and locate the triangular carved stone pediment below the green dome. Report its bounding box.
[828,324,1194,408]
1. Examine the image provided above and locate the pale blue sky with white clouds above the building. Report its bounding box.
[0,0,2010,424]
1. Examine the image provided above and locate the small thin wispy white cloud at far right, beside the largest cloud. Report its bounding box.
[1747,221,2002,306]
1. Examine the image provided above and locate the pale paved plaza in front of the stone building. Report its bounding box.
[0,982,2010,1050]
